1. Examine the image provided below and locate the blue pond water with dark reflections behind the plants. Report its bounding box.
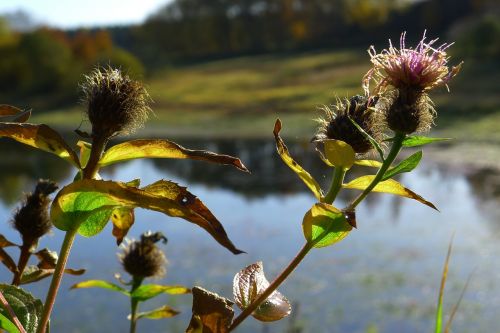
[0,136,500,333]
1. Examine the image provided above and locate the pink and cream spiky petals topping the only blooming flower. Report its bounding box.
[363,32,462,94]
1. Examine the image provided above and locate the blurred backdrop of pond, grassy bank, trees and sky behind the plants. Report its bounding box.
[0,0,500,333]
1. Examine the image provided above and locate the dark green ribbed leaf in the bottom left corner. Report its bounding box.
[0,284,43,333]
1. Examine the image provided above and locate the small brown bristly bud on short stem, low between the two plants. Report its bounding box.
[119,232,167,279]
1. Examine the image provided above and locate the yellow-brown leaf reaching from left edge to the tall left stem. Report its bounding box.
[0,123,80,169]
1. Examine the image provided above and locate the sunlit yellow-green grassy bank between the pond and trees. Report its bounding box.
[34,49,500,142]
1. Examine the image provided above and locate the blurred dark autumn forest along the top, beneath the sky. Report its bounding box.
[0,0,500,108]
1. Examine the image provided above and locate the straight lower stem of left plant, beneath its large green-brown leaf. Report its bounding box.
[37,226,78,333]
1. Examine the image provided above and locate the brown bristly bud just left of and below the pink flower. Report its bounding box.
[313,95,381,154]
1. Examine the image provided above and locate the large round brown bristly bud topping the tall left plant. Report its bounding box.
[81,67,151,139]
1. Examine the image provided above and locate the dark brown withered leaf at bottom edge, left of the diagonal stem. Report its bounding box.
[186,287,234,333]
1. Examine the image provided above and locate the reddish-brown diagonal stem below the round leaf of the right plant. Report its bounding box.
[228,242,314,332]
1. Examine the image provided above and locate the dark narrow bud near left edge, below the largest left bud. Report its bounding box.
[12,179,57,247]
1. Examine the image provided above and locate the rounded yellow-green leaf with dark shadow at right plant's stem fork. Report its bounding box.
[302,203,352,248]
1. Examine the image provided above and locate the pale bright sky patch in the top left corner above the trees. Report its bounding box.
[0,0,171,28]
